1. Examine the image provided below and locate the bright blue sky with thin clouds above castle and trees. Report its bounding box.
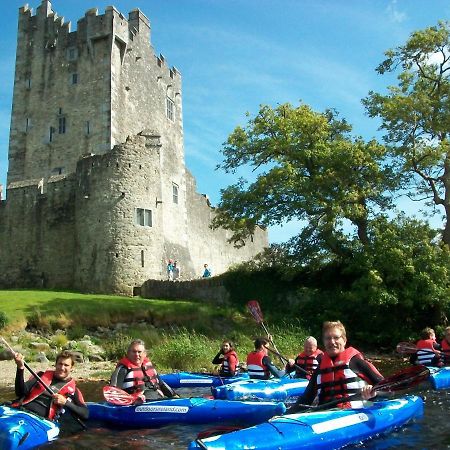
[0,0,450,242]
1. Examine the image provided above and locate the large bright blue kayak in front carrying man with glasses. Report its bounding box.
[189,396,423,450]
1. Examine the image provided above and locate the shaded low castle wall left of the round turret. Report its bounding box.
[0,177,75,288]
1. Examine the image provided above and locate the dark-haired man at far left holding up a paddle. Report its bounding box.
[11,350,89,420]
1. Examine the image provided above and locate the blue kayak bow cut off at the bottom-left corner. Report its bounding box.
[0,406,59,450]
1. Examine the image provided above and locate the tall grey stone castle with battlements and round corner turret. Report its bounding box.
[0,0,268,295]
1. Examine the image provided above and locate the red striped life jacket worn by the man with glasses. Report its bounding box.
[317,347,381,408]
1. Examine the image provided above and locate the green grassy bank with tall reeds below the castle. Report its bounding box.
[0,290,307,370]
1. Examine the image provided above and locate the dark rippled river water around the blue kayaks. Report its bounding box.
[0,382,450,450]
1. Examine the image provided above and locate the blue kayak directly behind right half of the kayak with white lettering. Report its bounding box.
[211,377,308,402]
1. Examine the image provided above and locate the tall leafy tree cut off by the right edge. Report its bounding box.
[363,22,450,245]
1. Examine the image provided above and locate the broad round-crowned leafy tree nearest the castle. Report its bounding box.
[214,104,395,260]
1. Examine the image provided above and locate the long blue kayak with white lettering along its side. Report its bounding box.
[88,397,286,428]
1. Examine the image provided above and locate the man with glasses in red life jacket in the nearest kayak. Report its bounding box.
[287,321,383,414]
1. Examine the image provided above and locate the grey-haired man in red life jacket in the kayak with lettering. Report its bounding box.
[110,339,178,401]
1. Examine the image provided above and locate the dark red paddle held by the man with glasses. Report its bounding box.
[297,366,430,411]
